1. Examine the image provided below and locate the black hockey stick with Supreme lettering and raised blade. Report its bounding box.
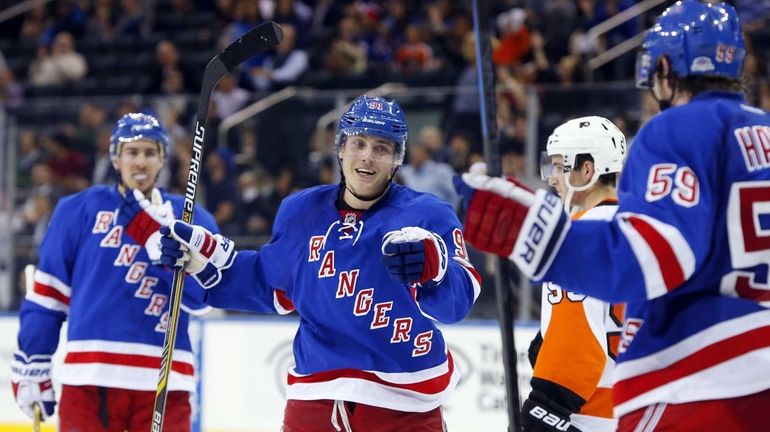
[150,21,283,432]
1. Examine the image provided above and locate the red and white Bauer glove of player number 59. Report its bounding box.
[454,172,570,280]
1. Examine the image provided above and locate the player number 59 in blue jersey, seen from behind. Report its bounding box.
[457,0,770,431]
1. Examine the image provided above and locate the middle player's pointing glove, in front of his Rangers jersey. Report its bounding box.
[382,227,449,286]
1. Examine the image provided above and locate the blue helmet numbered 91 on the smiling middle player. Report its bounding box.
[335,95,407,165]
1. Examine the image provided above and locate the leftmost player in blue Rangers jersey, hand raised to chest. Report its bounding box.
[11,114,217,432]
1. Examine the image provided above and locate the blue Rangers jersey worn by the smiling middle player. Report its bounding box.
[207,184,480,412]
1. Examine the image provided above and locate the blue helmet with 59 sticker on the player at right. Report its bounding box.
[636,0,746,88]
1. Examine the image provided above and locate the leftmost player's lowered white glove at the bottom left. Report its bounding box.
[11,351,56,420]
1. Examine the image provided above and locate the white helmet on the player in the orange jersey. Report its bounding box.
[540,116,627,211]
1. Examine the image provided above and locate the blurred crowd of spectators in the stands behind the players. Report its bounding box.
[0,0,770,310]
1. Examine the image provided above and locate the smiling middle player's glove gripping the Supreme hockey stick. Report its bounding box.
[160,221,237,288]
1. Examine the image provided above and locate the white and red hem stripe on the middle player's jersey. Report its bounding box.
[286,353,461,412]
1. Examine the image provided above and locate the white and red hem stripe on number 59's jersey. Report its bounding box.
[613,310,770,416]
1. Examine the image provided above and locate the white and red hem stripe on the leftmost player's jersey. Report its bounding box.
[59,340,195,392]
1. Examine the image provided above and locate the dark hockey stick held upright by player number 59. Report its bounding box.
[471,0,521,432]
